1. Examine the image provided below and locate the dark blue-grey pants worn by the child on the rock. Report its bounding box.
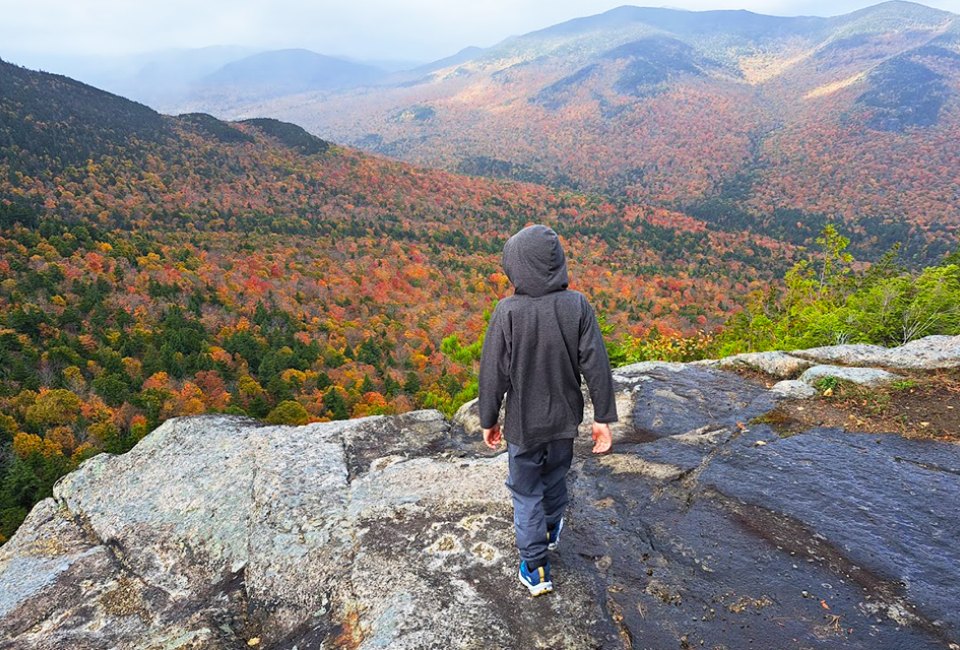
[507,438,573,562]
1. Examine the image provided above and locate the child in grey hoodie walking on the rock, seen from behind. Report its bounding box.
[479,225,617,596]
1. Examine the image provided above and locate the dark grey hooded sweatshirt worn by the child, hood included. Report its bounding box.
[480,225,617,449]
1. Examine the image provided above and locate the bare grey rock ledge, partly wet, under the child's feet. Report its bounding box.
[0,337,960,650]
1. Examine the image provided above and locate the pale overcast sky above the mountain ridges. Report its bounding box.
[0,0,960,64]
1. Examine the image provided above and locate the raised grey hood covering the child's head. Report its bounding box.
[503,225,568,297]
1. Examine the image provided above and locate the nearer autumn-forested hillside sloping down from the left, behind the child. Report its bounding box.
[0,57,792,541]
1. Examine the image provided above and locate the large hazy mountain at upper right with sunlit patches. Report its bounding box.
[219,2,960,261]
